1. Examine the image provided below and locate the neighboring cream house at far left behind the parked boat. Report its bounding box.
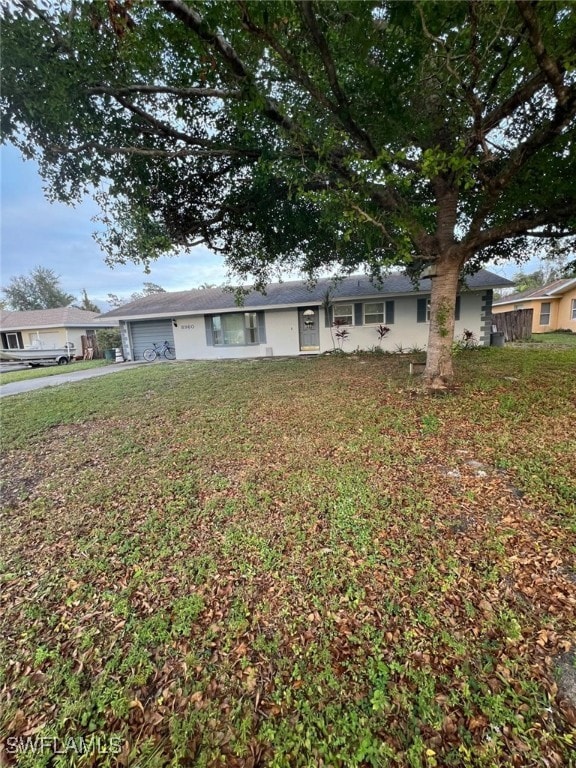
[0,307,118,355]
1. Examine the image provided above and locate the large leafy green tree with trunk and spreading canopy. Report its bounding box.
[2,0,576,387]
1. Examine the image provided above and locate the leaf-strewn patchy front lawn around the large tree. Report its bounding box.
[0,348,576,768]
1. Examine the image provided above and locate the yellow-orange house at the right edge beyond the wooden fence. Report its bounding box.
[492,277,576,333]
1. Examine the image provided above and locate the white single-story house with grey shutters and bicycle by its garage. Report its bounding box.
[102,270,512,360]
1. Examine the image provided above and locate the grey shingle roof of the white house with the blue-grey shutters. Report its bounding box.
[102,269,512,319]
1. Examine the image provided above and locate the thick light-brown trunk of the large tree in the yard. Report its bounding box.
[424,254,462,392]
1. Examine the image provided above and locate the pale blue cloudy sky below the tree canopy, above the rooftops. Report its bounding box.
[0,141,538,311]
